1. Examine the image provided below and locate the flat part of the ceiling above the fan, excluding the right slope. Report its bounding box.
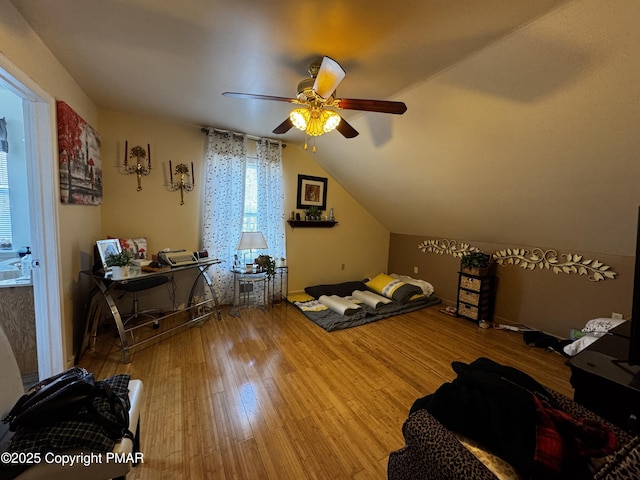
[12,0,562,142]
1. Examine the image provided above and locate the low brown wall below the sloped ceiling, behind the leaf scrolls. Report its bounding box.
[389,234,634,338]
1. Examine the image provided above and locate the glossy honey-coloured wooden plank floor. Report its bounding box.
[80,304,573,480]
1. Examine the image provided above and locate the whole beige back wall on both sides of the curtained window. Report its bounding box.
[96,111,389,291]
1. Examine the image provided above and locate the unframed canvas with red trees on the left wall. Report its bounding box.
[56,101,102,205]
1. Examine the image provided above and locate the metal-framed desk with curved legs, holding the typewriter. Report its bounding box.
[82,259,222,363]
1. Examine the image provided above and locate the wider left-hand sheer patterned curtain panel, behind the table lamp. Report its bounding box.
[201,129,247,304]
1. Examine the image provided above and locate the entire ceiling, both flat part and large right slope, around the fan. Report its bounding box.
[10,0,640,254]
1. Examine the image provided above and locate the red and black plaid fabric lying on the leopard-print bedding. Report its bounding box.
[533,395,618,480]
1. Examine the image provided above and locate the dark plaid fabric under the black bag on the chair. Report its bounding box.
[9,374,131,453]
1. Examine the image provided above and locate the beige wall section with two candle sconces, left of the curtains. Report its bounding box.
[94,110,206,253]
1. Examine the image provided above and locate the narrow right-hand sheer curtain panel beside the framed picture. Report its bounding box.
[256,138,286,259]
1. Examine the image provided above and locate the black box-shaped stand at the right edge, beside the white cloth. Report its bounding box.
[567,322,640,434]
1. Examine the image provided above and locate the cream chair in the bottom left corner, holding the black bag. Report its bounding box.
[0,327,142,480]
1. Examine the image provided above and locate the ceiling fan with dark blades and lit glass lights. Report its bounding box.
[222,57,407,142]
